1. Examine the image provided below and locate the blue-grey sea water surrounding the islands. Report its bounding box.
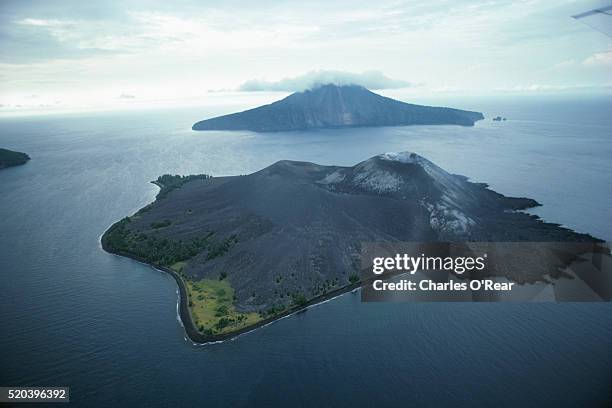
[0,98,612,407]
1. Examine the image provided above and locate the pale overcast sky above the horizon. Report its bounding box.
[0,0,612,110]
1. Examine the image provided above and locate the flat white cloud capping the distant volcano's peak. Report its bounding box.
[238,70,410,92]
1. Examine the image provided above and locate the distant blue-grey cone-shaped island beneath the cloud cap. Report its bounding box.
[192,84,484,132]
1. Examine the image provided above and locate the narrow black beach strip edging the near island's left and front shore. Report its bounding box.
[100,234,362,345]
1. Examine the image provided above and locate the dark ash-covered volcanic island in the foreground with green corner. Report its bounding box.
[102,152,600,343]
